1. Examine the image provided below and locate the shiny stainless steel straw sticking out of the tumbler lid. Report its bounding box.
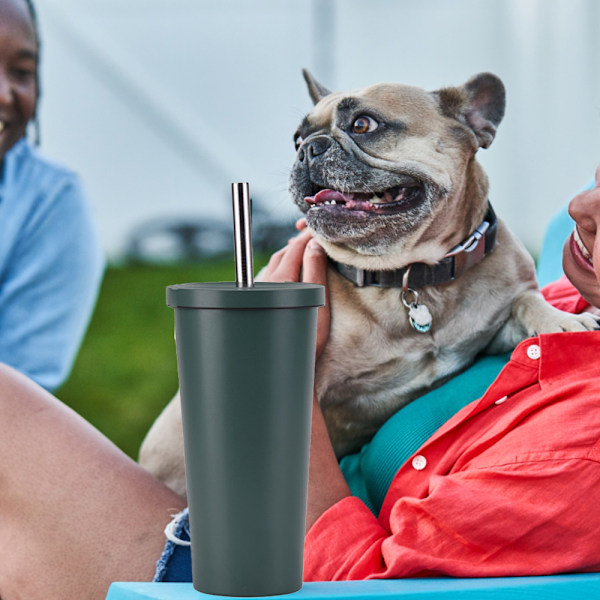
[231,183,254,287]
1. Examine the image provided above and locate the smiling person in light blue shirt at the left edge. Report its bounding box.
[0,0,104,390]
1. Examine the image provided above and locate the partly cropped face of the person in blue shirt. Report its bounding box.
[0,0,38,159]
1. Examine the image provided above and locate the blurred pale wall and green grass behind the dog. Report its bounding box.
[36,0,600,455]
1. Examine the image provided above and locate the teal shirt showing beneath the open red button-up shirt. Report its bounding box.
[340,354,510,515]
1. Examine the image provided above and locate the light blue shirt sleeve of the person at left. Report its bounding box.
[0,175,104,390]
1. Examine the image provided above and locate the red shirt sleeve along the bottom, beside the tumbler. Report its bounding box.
[304,458,600,581]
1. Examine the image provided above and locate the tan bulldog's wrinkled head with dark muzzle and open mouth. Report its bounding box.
[290,72,504,262]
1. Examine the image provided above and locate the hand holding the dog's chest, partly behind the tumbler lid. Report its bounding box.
[261,224,331,358]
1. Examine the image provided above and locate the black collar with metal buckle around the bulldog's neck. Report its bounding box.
[329,202,498,289]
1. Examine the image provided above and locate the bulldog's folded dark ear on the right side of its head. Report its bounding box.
[436,73,506,148]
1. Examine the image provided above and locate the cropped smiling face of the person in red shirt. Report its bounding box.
[563,166,600,307]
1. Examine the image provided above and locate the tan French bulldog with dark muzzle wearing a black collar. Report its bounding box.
[140,71,597,493]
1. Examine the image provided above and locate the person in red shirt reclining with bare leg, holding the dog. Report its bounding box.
[0,169,600,600]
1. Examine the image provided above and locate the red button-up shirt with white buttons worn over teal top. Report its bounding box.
[304,281,600,581]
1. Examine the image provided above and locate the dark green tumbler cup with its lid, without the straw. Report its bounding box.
[167,283,324,596]
